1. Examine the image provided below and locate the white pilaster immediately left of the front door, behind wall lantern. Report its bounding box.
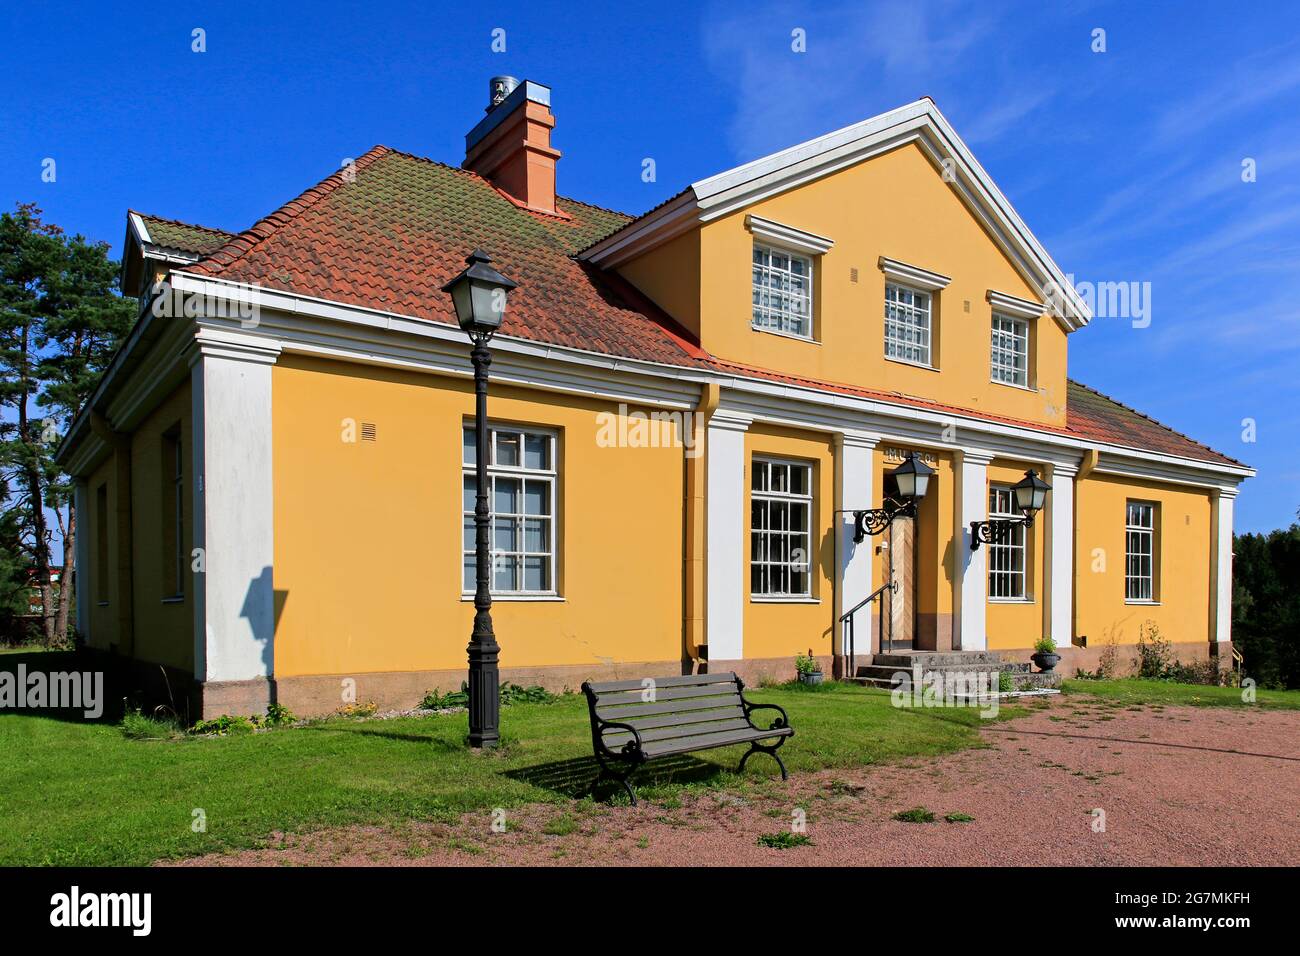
[833,432,880,657]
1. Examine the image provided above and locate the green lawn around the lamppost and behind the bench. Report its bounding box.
[0,684,1015,865]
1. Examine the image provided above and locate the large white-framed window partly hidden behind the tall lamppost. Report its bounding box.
[460,424,556,594]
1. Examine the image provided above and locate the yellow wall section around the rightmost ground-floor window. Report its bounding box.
[1075,475,1212,648]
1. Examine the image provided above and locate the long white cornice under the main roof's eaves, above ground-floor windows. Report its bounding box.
[60,273,1255,488]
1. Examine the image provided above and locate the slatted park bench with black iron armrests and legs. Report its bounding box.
[582,672,794,806]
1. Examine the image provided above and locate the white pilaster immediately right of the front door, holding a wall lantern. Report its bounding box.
[953,449,993,650]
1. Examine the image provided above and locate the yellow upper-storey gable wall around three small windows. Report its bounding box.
[619,144,1066,424]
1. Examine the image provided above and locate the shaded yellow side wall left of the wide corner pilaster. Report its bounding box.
[130,378,194,670]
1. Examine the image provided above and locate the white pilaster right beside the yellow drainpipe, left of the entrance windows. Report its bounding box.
[705,410,751,661]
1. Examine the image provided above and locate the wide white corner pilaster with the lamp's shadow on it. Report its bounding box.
[190,329,280,682]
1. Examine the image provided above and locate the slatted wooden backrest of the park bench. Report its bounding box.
[582,671,750,750]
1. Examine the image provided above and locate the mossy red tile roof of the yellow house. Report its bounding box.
[162,146,1240,466]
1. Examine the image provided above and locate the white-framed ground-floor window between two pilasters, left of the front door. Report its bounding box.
[749,458,813,597]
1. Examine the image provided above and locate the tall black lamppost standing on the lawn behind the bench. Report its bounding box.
[442,248,516,747]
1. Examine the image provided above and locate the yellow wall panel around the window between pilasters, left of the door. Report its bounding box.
[742,424,836,667]
